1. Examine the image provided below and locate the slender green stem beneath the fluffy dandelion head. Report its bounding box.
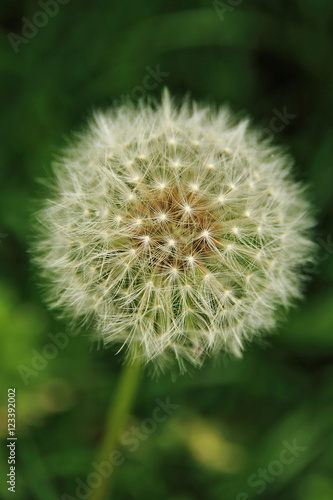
[89,361,142,500]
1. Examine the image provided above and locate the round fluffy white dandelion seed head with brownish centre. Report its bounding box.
[36,91,313,367]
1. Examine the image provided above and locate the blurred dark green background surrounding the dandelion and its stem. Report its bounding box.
[0,0,333,500]
